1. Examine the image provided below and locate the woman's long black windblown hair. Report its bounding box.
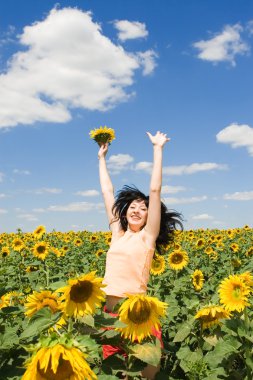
[112,185,183,253]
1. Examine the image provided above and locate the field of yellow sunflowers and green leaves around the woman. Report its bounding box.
[0,226,253,380]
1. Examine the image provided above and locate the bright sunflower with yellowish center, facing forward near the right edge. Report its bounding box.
[218,274,250,312]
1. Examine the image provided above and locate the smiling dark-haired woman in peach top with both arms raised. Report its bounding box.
[98,131,182,379]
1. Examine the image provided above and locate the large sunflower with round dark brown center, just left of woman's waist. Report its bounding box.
[57,271,105,317]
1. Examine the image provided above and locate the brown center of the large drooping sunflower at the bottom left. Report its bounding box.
[37,355,75,380]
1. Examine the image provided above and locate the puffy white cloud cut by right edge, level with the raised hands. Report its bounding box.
[216,123,253,156]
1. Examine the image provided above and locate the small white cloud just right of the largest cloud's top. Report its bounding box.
[114,20,148,41]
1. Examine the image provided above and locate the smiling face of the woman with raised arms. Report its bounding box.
[126,199,148,231]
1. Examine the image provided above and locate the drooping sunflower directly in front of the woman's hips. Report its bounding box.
[116,294,167,342]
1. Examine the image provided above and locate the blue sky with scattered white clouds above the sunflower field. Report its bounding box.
[0,0,253,233]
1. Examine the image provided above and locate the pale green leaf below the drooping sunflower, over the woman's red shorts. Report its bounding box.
[130,343,161,367]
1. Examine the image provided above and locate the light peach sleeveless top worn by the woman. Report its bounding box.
[103,231,155,297]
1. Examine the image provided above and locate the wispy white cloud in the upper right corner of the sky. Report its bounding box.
[193,24,249,66]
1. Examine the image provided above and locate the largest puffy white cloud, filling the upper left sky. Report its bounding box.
[0,8,154,128]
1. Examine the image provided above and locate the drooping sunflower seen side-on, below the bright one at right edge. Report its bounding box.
[194,305,230,330]
